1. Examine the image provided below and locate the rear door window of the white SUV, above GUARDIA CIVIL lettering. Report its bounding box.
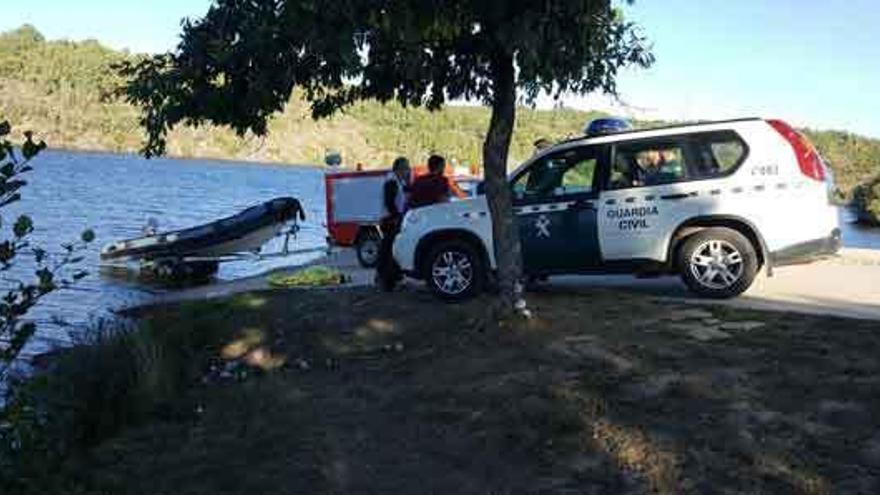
[608,139,692,190]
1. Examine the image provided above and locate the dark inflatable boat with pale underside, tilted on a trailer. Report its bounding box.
[101,197,305,262]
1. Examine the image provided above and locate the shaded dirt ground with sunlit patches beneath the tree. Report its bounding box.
[90,289,880,494]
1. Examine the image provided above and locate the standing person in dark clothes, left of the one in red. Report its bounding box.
[376,156,411,291]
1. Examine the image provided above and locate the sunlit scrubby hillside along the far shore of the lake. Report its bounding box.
[0,26,880,194]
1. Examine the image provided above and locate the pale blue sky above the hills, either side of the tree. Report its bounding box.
[0,0,880,137]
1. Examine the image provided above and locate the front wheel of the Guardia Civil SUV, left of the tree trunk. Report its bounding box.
[424,240,486,301]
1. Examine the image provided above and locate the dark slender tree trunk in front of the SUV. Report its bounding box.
[483,55,522,313]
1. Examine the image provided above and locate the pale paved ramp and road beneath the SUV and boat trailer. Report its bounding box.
[129,248,880,320]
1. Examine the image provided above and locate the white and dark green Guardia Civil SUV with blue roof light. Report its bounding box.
[394,119,840,300]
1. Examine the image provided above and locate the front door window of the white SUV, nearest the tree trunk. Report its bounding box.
[513,148,599,199]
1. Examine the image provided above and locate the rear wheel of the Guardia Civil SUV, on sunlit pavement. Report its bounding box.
[677,227,758,299]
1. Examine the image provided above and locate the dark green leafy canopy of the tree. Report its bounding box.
[118,0,653,156]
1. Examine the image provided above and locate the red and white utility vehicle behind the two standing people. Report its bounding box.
[324,166,479,268]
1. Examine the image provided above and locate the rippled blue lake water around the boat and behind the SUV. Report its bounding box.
[3,151,880,354]
